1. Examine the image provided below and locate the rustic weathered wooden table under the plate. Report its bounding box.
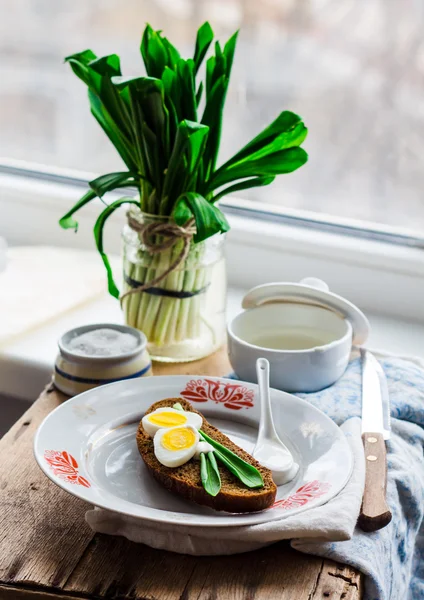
[0,351,362,600]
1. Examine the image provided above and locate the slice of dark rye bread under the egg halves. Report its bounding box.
[137,398,277,513]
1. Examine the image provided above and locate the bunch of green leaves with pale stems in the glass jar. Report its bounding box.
[60,23,307,346]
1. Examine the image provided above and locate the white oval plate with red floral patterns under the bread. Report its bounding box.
[34,376,353,527]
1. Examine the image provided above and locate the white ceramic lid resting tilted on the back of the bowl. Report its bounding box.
[242,277,370,346]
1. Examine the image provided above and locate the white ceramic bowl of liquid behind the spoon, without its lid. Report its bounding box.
[228,302,352,392]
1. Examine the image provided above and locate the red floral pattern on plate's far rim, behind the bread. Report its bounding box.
[181,379,255,410]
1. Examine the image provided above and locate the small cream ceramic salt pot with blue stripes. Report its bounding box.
[53,323,152,396]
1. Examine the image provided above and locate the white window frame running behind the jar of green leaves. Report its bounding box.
[0,161,424,321]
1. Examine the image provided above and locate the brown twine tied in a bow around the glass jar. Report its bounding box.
[120,212,196,306]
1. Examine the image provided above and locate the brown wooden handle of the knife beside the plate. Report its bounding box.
[358,433,392,531]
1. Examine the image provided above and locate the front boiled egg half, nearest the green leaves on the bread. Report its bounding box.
[152,424,199,467]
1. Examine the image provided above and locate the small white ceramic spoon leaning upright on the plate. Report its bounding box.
[253,358,299,485]
